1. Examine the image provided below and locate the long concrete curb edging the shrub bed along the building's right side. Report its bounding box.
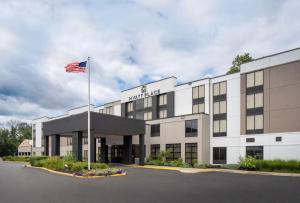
[130,165,300,177]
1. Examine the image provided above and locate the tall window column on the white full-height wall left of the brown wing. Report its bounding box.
[213,81,227,137]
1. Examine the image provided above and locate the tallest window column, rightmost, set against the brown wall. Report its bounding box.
[246,71,264,134]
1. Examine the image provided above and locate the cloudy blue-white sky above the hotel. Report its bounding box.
[0,0,300,126]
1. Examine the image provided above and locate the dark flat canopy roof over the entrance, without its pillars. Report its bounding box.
[43,112,145,136]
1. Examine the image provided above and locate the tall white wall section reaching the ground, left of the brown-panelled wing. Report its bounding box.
[210,73,241,164]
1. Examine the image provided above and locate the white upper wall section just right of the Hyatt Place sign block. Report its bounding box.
[175,79,210,116]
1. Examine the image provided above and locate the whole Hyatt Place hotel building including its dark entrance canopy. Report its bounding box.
[32,48,300,164]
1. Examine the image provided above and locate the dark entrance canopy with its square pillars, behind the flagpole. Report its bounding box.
[43,112,145,165]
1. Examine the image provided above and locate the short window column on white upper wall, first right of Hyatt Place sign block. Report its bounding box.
[193,85,205,113]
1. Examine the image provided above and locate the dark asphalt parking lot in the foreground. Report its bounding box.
[0,162,300,203]
